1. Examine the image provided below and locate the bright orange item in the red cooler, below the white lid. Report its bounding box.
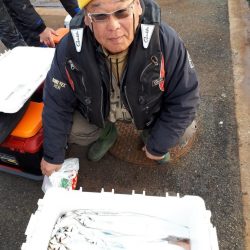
[11,102,43,138]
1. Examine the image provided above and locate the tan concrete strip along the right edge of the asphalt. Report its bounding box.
[229,0,250,249]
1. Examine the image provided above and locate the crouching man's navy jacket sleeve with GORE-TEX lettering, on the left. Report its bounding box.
[43,37,76,164]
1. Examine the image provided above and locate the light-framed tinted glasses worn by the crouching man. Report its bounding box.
[87,0,134,22]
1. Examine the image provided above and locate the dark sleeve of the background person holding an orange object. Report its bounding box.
[5,0,46,34]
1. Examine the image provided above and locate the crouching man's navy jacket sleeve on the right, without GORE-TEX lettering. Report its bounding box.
[146,25,199,156]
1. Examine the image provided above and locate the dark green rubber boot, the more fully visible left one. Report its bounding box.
[88,122,117,161]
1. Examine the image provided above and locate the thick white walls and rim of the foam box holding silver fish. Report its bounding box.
[21,188,219,250]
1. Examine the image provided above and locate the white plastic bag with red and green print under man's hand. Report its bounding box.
[42,158,79,193]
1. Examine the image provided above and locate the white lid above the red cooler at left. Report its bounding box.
[0,47,55,113]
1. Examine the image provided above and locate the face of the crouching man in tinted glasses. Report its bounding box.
[85,0,142,54]
